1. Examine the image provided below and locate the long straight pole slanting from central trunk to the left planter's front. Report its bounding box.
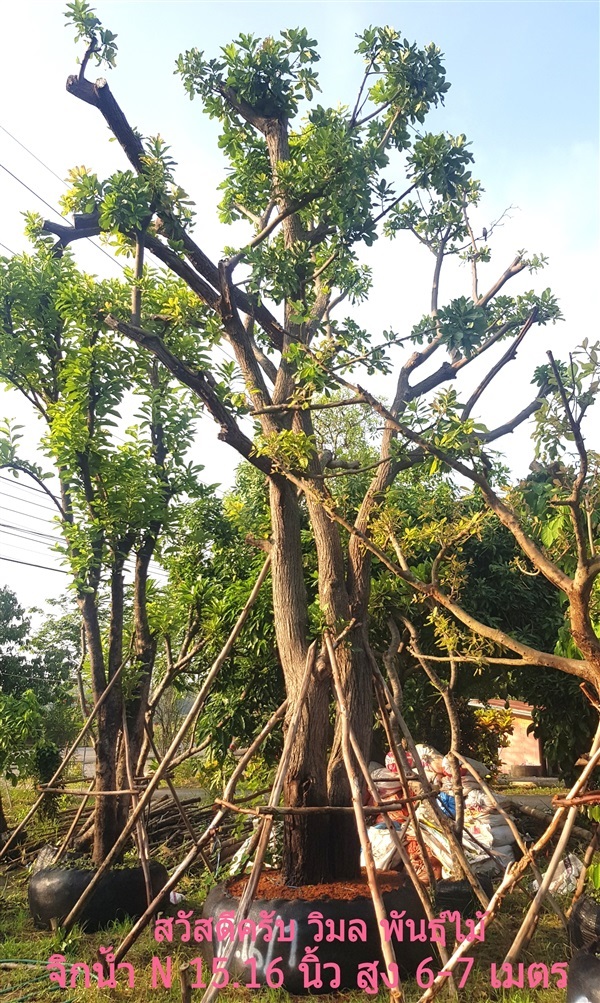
[63,556,271,930]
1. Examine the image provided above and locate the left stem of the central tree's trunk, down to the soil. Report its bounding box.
[270,476,329,885]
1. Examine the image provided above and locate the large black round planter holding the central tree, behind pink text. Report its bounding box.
[202,882,437,996]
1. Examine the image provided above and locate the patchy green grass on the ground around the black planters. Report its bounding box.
[0,787,577,1003]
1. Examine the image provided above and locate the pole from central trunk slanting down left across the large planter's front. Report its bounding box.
[201,641,317,1003]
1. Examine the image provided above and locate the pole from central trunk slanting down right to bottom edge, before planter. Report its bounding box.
[324,631,405,1003]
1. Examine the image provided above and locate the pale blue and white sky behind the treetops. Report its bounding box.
[0,0,600,602]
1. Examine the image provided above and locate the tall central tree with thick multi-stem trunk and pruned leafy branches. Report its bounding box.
[46,7,597,885]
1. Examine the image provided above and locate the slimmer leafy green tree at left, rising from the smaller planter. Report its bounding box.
[0,232,206,863]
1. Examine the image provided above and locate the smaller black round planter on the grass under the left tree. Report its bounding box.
[28,862,169,932]
